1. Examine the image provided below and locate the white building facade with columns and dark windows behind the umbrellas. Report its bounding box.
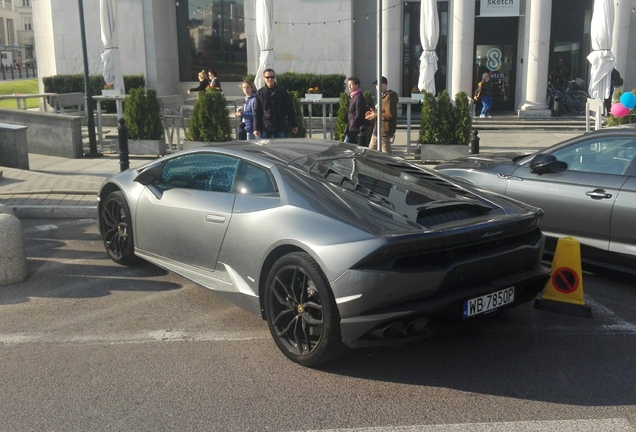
[32,0,636,116]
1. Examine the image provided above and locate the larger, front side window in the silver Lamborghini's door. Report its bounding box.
[158,153,239,192]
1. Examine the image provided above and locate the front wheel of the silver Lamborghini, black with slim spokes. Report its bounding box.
[99,191,138,265]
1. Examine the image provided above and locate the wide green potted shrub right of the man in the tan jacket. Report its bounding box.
[419,90,472,161]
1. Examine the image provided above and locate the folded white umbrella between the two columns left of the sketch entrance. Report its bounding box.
[417,0,439,94]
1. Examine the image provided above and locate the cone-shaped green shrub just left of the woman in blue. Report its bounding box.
[183,87,232,149]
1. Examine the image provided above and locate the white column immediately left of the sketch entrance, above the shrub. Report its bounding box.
[447,0,475,99]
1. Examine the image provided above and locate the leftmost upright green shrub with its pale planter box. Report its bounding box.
[124,88,166,156]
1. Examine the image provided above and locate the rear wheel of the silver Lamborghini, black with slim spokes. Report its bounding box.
[264,252,346,367]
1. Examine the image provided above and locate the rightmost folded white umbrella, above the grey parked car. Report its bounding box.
[587,0,616,100]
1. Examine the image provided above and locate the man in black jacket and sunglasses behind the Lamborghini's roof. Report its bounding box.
[254,69,298,138]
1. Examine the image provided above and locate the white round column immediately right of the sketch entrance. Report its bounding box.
[519,0,552,117]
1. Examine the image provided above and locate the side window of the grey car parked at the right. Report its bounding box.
[552,137,636,175]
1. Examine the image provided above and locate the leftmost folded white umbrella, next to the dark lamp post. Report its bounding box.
[99,0,126,118]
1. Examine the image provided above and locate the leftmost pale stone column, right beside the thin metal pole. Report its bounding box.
[382,0,404,94]
